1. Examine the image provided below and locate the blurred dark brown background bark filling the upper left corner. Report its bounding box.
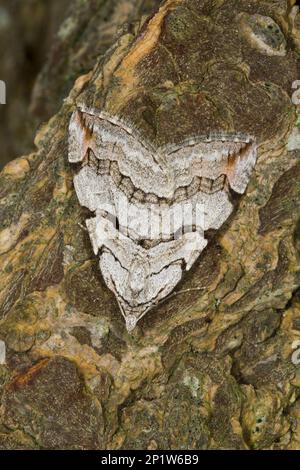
[0,0,159,167]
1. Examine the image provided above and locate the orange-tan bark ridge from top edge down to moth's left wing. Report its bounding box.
[108,0,182,113]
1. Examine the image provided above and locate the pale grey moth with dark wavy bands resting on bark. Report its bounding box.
[69,107,257,331]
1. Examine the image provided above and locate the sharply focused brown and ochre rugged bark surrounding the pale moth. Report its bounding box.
[0,0,300,449]
